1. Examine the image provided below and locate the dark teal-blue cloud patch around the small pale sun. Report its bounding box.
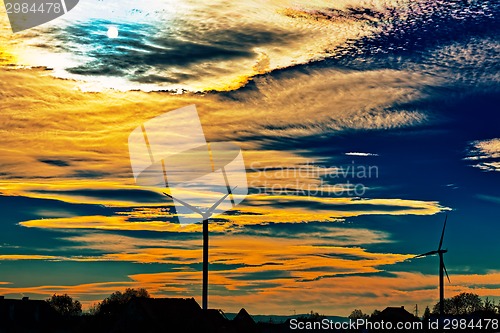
[46,20,290,83]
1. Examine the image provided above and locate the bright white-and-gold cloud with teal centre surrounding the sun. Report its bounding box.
[1,0,373,91]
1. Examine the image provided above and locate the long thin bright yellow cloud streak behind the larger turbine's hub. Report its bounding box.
[14,195,448,232]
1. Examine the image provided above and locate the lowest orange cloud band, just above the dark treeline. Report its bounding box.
[0,271,500,316]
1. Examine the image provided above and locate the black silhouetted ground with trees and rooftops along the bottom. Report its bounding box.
[0,289,500,333]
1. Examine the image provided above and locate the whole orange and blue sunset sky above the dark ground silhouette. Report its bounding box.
[0,0,500,315]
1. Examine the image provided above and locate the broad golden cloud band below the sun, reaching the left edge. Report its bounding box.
[0,65,436,192]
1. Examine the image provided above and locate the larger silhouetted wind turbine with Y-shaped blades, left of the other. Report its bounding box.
[163,186,236,310]
